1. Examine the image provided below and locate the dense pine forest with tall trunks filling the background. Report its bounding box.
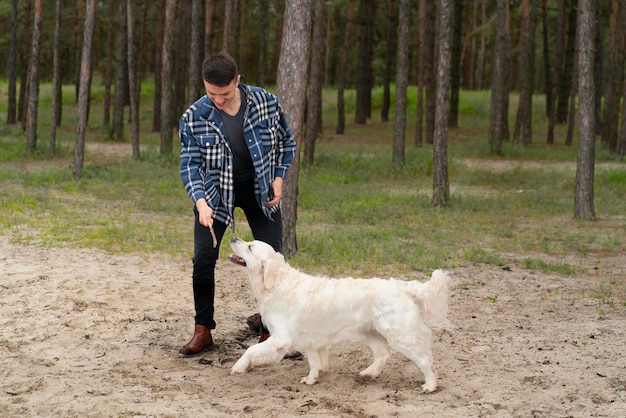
[0,0,626,229]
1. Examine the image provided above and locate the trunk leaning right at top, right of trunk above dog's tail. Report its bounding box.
[489,0,509,155]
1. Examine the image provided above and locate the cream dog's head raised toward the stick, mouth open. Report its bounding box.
[228,237,285,289]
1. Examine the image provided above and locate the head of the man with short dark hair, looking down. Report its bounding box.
[202,52,241,110]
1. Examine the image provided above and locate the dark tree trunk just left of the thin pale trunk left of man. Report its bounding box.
[112,0,128,141]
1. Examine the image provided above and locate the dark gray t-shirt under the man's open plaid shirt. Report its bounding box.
[220,86,254,183]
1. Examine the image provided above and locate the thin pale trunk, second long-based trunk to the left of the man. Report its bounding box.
[126,0,141,159]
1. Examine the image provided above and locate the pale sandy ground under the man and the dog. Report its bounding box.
[0,236,626,417]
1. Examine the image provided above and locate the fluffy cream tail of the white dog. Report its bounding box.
[411,270,452,329]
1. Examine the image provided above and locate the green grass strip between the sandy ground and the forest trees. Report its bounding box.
[0,82,626,280]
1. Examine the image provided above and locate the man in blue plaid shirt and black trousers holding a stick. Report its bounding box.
[179,53,296,356]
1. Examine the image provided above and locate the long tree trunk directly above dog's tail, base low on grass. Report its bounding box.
[432,0,453,206]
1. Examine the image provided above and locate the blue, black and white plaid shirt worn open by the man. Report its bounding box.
[178,84,296,230]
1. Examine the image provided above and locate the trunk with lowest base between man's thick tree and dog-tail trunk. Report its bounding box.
[393,0,411,165]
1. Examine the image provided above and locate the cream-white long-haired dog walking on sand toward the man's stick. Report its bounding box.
[228,237,451,392]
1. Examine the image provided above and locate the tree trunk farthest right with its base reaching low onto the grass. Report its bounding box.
[574,0,596,221]
